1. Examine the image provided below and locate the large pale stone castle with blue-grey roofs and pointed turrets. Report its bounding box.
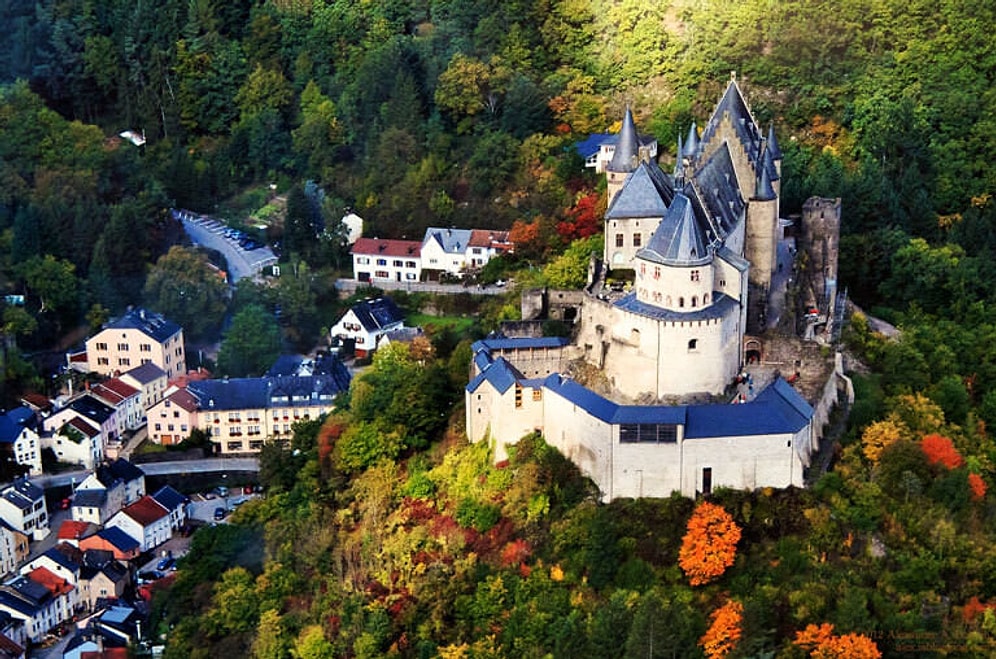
[465,76,832,500]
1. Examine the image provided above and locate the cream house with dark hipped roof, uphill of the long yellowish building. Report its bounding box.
[86,309,187,378]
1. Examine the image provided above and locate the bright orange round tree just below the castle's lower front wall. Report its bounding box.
[678,501,740,586]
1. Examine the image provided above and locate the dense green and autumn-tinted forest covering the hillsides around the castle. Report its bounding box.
[0,0,996,657]
